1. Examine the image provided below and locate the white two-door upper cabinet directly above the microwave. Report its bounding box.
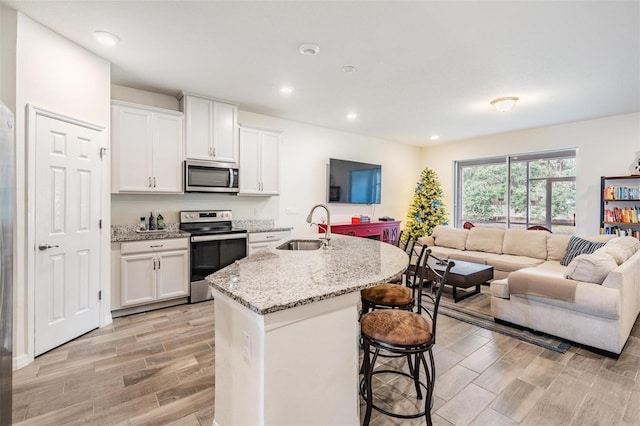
[180,94,238,164]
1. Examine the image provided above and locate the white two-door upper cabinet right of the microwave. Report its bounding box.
[239,126,281,195]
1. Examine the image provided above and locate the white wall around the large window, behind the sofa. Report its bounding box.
[422,113,640,235]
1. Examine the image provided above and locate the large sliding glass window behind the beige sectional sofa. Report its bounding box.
[454,150,576,234]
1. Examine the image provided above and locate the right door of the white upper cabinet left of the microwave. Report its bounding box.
[153,113,183,192]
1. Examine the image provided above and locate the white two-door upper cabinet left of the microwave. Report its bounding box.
[111,101,184,193]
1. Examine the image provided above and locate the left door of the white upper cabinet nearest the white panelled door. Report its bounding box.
[111,106,153,192]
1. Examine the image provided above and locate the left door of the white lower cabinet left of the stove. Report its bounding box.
[120,253,157,307]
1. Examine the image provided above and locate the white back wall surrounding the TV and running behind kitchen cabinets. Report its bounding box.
[111,86,421,233]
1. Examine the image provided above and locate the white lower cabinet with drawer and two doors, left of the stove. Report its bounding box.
[114,238,189,308]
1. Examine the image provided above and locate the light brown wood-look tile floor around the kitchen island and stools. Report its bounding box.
[13,302,640,426]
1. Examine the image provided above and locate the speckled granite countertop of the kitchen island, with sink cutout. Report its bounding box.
[207,234,409,315]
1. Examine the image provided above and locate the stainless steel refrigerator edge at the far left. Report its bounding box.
[0,102,15,425]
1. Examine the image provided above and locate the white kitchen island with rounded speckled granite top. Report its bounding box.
[207,235,409,426]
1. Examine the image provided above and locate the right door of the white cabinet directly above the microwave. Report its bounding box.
[213,102,238,164]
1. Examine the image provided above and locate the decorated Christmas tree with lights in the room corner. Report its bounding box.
[403,167,447,238]
